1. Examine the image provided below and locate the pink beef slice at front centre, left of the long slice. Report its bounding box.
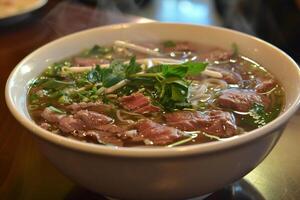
[136,119,180,145]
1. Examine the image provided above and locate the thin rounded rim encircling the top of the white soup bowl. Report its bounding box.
[5,22,300,158]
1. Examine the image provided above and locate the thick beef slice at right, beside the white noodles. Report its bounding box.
[218,89,270,112]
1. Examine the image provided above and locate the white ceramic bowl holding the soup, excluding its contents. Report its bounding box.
[6,23,300,199]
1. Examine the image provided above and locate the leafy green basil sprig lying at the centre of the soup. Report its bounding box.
[129,62,207,111]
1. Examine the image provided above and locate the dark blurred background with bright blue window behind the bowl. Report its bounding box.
[79,0,300,62]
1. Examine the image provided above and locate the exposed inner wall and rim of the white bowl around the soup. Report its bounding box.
[6,23,300,156]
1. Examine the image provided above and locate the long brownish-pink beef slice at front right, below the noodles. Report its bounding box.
[164,110,237,137]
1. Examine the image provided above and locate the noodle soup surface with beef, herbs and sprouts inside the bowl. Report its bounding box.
[28,41,284,147]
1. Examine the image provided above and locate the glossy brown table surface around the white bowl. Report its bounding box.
[0,0,300,200]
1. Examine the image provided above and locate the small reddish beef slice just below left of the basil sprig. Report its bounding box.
[119,92,160,114]
